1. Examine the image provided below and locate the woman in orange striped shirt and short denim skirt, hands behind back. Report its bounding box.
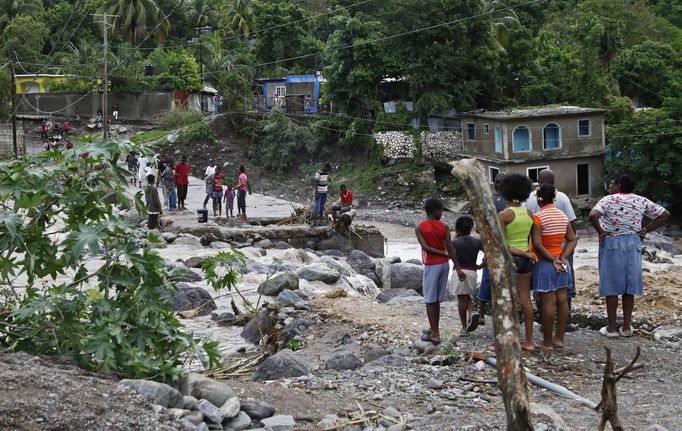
[531,184,578,349]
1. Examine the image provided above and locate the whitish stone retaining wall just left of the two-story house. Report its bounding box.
[374,131,464,161]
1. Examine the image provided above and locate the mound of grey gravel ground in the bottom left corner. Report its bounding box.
[0,353,185,431]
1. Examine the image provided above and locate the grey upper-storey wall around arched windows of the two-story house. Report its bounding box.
[462,113,604,160]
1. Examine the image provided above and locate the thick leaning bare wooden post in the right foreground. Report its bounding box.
[450,159,533,431]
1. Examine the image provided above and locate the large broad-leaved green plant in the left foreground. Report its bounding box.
[0,142,219,380]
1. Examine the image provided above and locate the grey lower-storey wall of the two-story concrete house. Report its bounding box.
[481,156,604,198]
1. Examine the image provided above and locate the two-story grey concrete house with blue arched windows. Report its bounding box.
[460,106,605,198]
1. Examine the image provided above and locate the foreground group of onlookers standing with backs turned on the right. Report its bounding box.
[416,169,669,351]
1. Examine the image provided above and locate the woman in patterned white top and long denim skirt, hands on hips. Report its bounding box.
[590,174,670,337]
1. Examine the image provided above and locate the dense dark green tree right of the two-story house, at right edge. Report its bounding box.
[606,109,682,208]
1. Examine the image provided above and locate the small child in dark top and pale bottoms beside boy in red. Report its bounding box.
[450,216,483,337]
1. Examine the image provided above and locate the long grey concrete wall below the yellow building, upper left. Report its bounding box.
[15,92,173,121]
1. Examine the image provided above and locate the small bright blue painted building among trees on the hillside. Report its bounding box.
[261,74,322,113]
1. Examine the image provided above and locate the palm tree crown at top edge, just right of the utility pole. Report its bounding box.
[99,0,170,43]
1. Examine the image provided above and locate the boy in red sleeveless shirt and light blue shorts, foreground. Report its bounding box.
[414,199,466,344]
